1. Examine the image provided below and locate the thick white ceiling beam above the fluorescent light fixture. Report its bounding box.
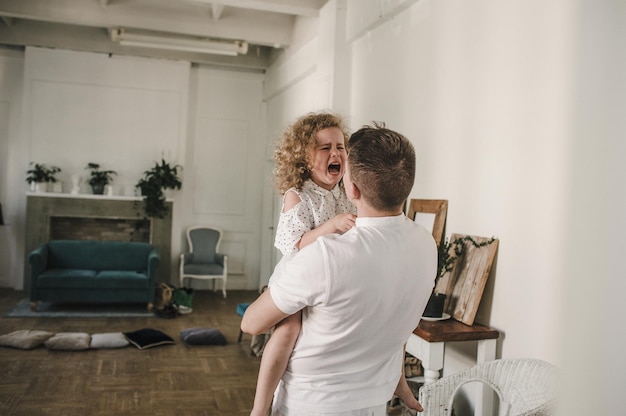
[0,0,295,46]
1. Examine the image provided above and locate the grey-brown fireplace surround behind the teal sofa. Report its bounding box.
[24,192,173,291]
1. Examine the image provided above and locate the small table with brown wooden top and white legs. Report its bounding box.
[406,318,500,415]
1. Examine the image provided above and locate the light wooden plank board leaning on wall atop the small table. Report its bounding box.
[435,234,498,325]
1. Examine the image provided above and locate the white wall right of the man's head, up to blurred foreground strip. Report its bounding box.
[348,0,573,372]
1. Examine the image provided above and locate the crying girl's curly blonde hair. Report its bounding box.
[274,113,350,194]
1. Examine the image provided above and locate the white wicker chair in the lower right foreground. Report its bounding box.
[405,359,557,416]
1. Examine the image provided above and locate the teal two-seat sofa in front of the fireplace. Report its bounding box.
[28,240,160,310]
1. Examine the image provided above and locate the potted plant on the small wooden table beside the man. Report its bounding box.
[422,235,495,318]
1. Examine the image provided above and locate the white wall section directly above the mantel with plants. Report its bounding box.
[22,48,190,195]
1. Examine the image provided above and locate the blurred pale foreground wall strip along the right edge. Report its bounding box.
[558,0,626,416]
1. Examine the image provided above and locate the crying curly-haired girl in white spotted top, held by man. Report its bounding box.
[251,113,356,416]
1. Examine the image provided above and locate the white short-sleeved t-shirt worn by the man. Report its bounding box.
[270,215,437,412]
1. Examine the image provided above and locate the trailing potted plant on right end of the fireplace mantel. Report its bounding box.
[135,159,183,218]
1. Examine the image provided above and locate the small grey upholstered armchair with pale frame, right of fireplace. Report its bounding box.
[180,225,228,298]
